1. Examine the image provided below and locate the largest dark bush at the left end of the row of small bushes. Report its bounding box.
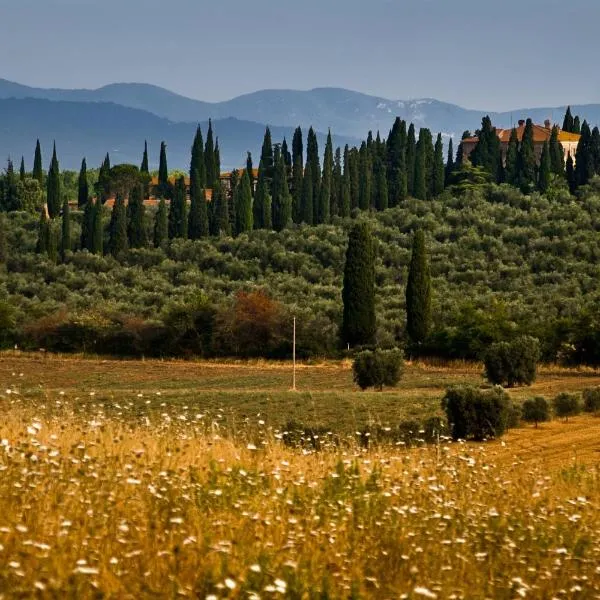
[442,386,512,441]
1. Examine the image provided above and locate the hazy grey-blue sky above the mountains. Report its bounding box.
[0,0,600,111]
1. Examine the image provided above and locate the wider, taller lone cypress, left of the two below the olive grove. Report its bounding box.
[341,223,376,346]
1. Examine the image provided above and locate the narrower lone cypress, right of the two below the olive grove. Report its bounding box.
[406,230,431,346]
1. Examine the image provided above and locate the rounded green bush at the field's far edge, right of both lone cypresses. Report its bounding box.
[484,335,540,387]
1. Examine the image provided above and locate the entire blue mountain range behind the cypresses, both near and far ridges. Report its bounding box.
[0,79,600,168]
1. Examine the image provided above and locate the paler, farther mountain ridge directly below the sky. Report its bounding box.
[0,79,600,138]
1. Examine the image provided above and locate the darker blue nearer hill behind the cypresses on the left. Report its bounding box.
[0,98,357,169]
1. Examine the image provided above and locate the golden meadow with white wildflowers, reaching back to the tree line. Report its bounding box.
[0,353,600,599]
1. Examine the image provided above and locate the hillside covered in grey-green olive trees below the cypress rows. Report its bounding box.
[0,183,600,362]
